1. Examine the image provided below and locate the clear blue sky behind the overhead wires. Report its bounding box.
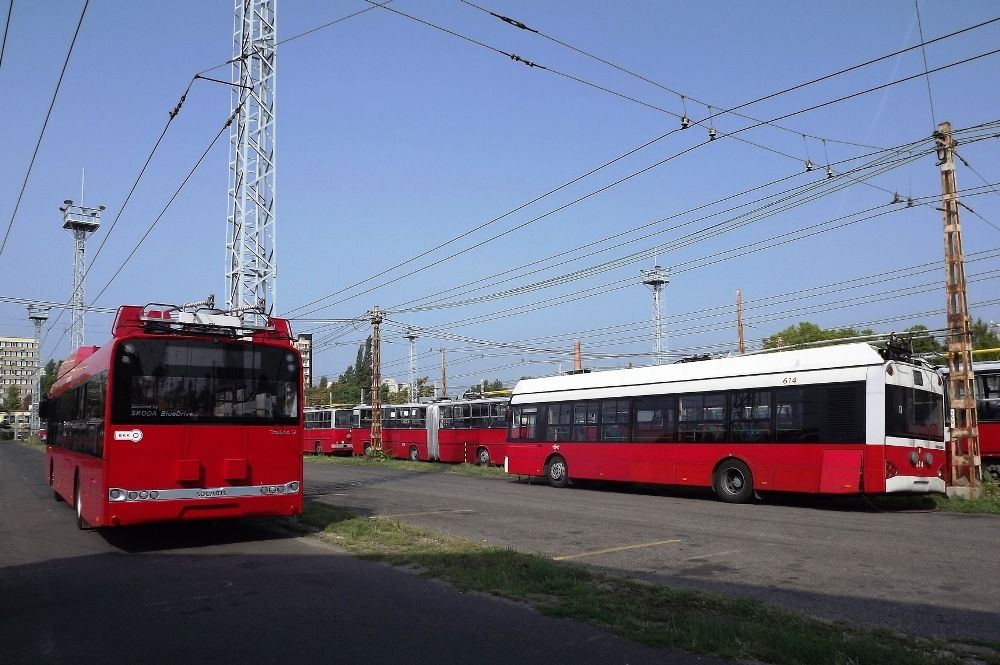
[0,0,1000,391]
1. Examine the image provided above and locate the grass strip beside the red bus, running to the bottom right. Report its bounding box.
[301,502,1000,665]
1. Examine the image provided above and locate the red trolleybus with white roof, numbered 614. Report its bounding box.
[504,344,946,503]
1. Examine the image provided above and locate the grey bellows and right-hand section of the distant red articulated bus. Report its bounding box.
[427,398,509,466]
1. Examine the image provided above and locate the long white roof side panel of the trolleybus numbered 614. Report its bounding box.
[514,343,885,402]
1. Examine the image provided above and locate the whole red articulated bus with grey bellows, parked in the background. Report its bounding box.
[351,398,509,465]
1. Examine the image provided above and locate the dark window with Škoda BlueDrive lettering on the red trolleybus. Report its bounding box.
[111,339,299,425]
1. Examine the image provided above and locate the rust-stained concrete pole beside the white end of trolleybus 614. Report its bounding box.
[934,122,983,498]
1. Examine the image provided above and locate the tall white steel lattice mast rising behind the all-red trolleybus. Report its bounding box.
[226,0,278,324]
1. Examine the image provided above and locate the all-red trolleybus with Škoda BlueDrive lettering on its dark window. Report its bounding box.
[43,305,302,528]
